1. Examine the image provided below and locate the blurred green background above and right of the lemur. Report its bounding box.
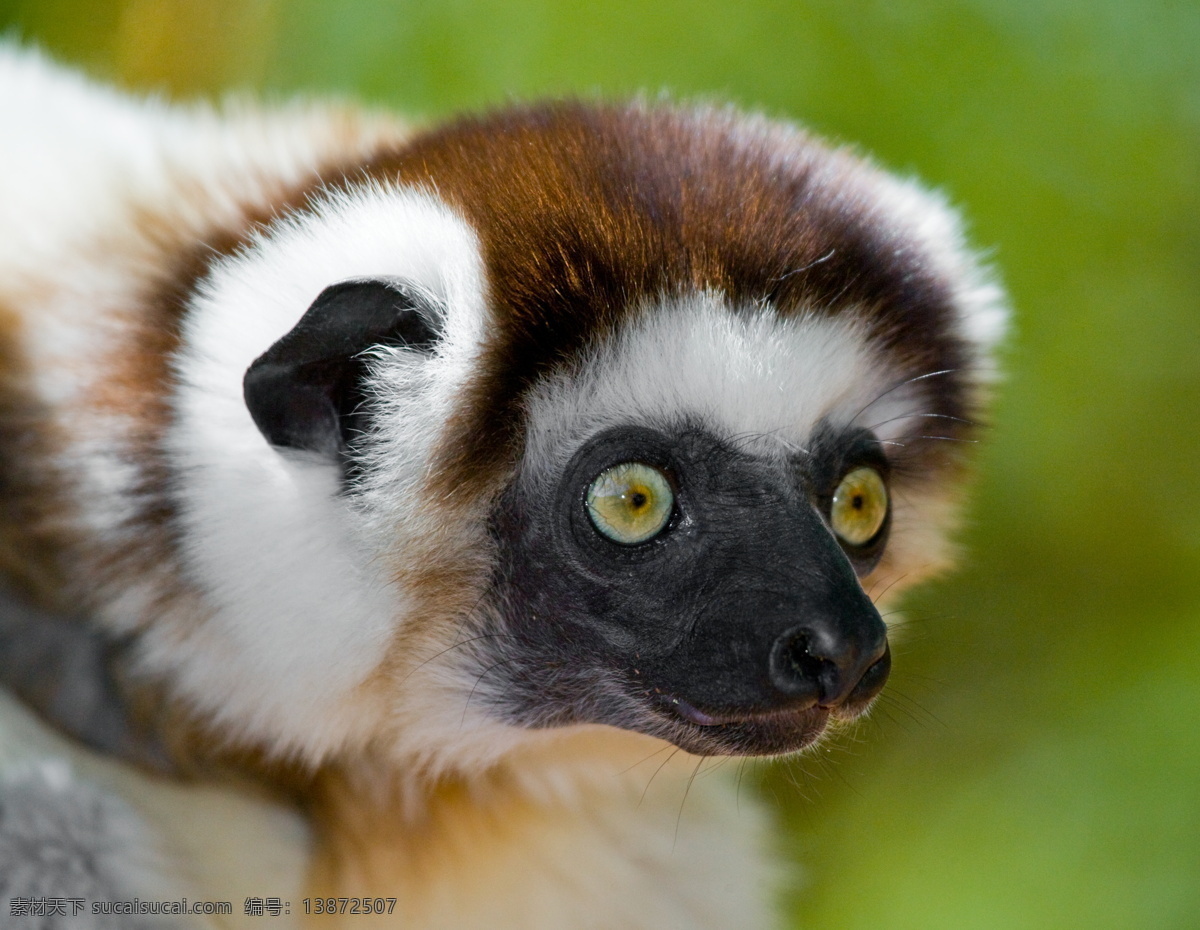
[0,0,1200,930]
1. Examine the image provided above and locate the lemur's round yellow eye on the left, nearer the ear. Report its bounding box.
[588,462,674,546]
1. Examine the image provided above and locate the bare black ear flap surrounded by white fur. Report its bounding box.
[242,278,437,458]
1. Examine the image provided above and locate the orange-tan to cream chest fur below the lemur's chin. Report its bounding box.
[310,727,776,930]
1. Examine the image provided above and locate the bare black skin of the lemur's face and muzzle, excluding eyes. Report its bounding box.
[486,426,890,755]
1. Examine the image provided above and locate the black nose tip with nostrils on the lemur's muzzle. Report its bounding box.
[769,623,892,708]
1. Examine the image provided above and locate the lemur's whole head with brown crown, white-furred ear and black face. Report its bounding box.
[180,104,1003,772]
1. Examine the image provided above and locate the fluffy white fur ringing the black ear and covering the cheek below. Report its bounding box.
[159,188,481,758]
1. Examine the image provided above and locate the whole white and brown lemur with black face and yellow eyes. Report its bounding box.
[0,46,1006,930]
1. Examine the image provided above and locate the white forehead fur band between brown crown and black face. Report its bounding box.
[526,293,895,474]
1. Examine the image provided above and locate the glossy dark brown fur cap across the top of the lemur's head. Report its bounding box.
[349,103,968,508]
